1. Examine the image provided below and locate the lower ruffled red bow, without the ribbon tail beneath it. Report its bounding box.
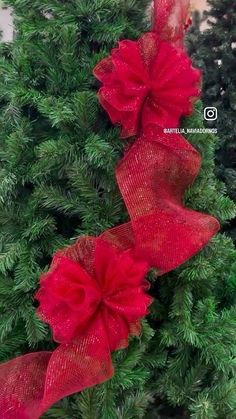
[36,238,151,352]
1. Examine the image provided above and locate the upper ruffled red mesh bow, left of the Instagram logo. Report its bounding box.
[94,32,200,137]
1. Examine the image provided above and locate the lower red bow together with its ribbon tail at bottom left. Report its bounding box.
[0,237,151,419]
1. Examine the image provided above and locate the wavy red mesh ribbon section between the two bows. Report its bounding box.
[102,126,219,274]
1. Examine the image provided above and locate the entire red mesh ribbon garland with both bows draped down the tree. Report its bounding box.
[0,0,219,419]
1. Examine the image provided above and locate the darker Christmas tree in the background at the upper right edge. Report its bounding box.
[190,0,236,239]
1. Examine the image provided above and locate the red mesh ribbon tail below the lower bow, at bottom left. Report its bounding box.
[0,322,114,419]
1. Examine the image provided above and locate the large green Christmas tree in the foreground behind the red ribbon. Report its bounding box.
[0,0,236,419]
